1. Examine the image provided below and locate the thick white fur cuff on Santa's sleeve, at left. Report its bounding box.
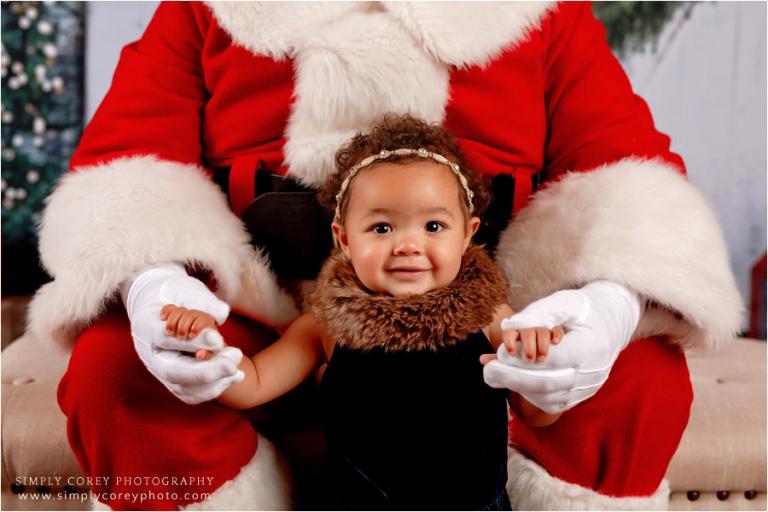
[29,156,298,344]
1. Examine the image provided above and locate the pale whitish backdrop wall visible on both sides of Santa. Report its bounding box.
[85,2,766,327]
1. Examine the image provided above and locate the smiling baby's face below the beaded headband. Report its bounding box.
[334,159,480,296]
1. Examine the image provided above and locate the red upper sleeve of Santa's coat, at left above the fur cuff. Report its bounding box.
[70,2,210,169]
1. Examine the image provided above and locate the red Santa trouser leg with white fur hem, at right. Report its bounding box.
[507,338,693,510]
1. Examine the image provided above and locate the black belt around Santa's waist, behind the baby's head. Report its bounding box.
[214,167,541,279]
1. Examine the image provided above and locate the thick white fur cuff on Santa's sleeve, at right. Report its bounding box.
[497,158,743,347]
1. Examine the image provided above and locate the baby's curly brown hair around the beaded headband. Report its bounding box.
[317,114,489,219]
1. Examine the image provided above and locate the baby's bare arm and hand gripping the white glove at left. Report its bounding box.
[161,304,325,409]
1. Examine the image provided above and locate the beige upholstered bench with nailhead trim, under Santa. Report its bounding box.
[2,330,766,510]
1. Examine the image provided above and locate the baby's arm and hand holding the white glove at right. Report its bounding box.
[480,304,565,427]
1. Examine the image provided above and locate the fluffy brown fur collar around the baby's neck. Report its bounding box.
[310,246,507,351]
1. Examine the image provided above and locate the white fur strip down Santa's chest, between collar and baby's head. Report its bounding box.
[284,8,448,186]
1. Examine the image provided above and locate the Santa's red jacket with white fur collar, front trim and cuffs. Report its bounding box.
[29,2,742,356]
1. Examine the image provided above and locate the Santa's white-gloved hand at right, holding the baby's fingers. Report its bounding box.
[483,281,642,414]
